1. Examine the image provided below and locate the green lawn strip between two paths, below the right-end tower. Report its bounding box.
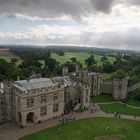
[100,103,140,116]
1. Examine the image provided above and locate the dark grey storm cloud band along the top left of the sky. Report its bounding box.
[0,0,115,17]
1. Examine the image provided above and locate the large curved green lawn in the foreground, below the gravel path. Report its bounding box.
[20,118,140,140]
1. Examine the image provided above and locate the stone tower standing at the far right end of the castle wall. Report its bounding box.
[113,78,128,100]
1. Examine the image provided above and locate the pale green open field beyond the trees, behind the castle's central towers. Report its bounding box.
[51,52,115,66]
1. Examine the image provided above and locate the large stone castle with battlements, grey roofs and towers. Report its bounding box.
[0,66,128,127]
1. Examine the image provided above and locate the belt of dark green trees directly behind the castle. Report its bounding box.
[0,48,140,85]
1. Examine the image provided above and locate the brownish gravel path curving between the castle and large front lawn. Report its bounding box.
[0,105,140,140]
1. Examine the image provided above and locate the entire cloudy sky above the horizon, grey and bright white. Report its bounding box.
[0,0,140,50]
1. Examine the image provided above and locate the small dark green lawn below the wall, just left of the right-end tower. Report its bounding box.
[92,95,114,103]
